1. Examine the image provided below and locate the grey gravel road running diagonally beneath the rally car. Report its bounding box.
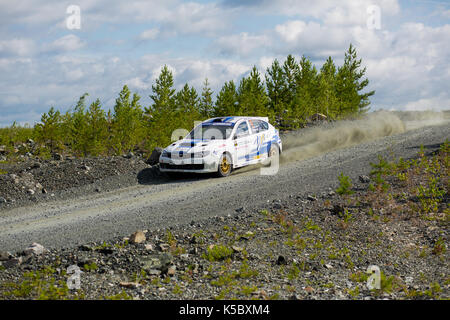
[0,114,450,251]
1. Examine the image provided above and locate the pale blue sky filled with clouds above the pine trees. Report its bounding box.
[0,0,450,126]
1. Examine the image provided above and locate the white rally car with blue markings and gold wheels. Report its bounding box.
[159,117,282,177]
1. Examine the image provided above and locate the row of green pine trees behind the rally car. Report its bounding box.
[0,45,374,156]
